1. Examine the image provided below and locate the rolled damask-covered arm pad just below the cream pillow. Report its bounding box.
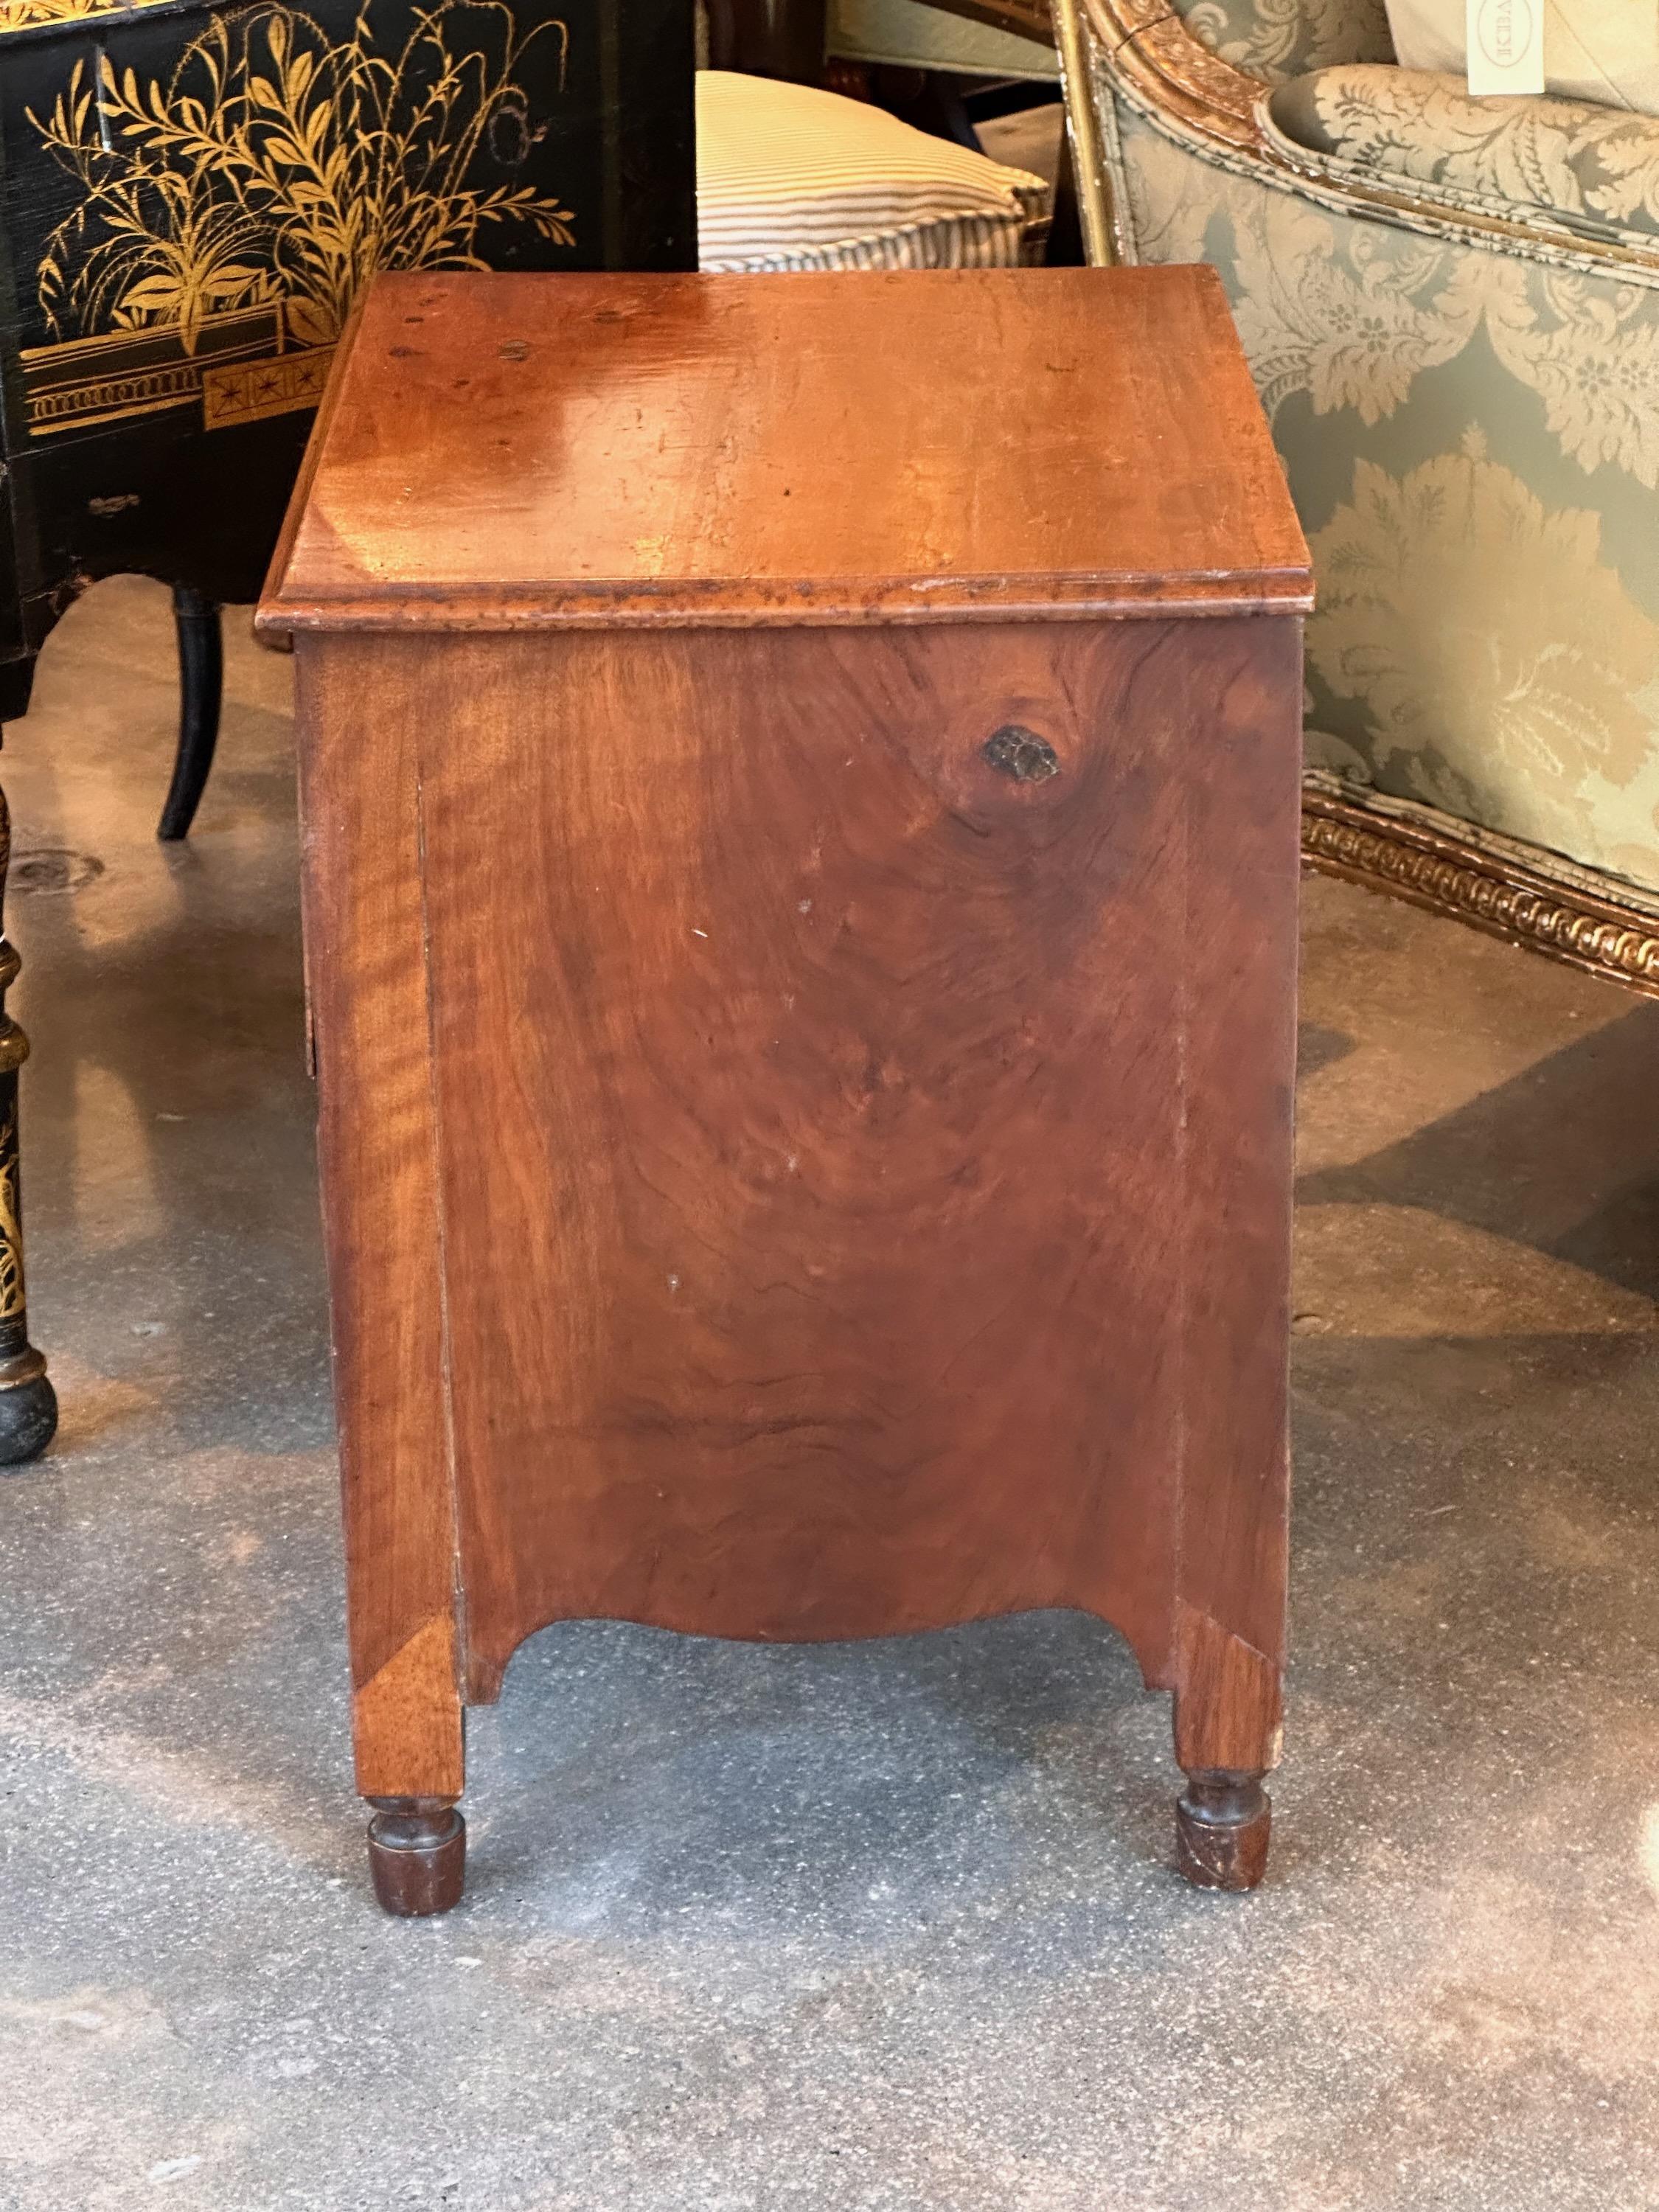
[1267,69,1659,246]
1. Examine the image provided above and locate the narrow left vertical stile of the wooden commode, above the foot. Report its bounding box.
[301,653,462,1798]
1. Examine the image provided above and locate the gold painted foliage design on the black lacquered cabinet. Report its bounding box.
[29,0,573,354]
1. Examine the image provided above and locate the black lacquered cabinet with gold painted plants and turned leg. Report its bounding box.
[0,0,697,1460]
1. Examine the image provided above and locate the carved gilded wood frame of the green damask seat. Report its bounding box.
[1053,0,1659,995]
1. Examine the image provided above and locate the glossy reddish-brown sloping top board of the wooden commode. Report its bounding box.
[261,268,1310,630]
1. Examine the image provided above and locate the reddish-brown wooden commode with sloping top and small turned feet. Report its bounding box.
[259,268,1310,1913]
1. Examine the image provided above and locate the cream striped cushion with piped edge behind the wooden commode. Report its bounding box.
[697,69,1048,270]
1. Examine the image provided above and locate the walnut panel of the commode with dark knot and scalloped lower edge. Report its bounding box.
[301,617,1301,1796]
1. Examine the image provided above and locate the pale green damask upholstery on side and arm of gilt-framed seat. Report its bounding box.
[1113,88,1659,891]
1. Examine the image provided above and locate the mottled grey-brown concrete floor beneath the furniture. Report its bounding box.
[0,582,1659,2212]
